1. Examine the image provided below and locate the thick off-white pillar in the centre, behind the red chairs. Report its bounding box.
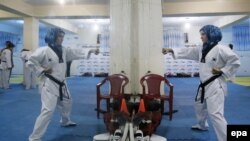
[110,0,164,93]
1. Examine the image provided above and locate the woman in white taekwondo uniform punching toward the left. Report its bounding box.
[162,25,240,141]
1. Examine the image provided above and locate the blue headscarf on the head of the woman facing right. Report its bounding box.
[45,28,65,47]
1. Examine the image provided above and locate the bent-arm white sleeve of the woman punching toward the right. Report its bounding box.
[26,49,46,76]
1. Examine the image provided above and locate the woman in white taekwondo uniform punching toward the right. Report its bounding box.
[27,28,99,141]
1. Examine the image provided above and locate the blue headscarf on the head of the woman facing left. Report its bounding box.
[200,25,222,45]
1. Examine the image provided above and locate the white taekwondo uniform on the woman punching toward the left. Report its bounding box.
[174,45,240,141]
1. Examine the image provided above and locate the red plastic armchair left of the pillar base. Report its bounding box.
[96,74,129,118]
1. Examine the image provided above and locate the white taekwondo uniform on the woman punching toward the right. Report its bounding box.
[27,47,88,141]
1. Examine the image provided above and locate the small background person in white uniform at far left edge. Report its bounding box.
[0,41,15,89]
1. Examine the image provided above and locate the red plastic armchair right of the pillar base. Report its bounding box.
[140,74,174,120]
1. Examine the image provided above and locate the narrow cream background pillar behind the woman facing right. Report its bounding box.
[23,17,39,50]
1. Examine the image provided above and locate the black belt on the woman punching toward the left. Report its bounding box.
[195,73,222,103]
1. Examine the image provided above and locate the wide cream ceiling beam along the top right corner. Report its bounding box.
[163,0,250,16]
